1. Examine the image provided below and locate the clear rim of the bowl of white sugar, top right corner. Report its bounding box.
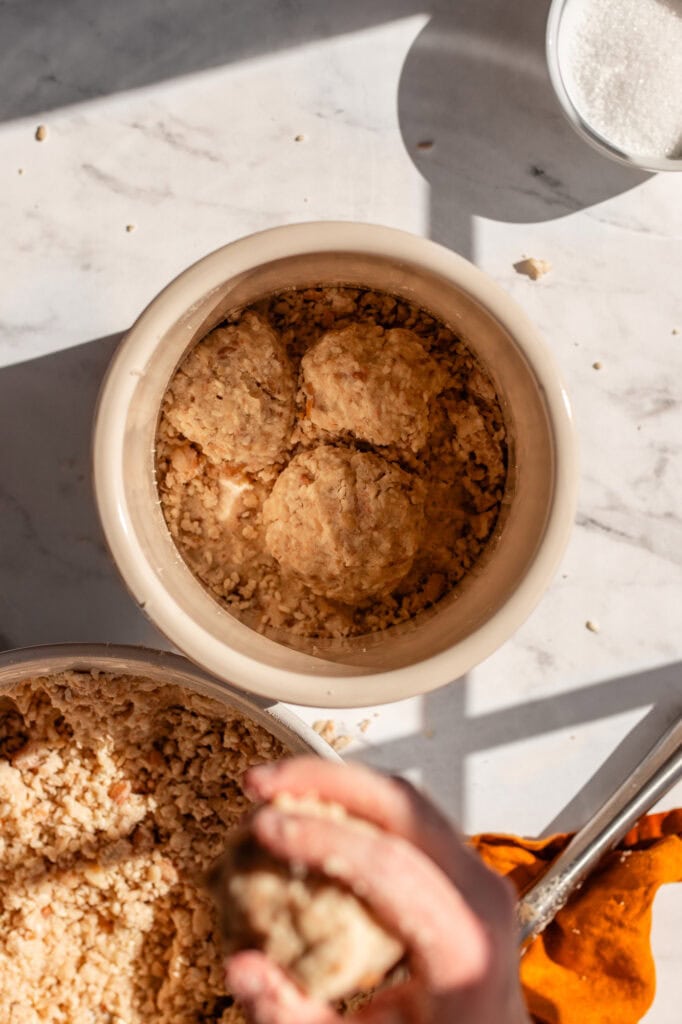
[545,0,682,174]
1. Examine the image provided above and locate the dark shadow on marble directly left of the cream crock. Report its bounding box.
[0,335,167,649]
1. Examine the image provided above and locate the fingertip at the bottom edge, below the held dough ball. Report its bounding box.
[225,949,341,1024]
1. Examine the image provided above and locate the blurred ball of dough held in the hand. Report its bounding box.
[209,801,404,1000]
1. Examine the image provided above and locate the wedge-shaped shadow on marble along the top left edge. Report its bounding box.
[0,0,430,120]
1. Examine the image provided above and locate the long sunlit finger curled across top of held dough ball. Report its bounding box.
[251,807,491,991]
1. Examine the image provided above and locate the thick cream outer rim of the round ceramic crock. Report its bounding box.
[93,221,578,708]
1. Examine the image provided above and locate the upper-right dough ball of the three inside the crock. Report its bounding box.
[301,324,444,452]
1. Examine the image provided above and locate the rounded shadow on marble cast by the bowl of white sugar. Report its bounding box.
[398,0,648,256]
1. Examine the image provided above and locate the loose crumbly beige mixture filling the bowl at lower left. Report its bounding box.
[0,672,286,1024]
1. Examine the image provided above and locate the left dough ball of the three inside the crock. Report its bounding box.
[166,312,295,472]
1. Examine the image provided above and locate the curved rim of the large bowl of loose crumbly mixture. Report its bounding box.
[0,643,343,763]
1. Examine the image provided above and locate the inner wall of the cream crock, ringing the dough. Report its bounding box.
[115,252,555,676]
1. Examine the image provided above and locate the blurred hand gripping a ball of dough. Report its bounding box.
[227,758,529,1024]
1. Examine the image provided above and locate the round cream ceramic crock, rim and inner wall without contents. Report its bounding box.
[94,222,577,707]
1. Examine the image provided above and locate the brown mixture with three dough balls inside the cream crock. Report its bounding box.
[157,287,507,638]
